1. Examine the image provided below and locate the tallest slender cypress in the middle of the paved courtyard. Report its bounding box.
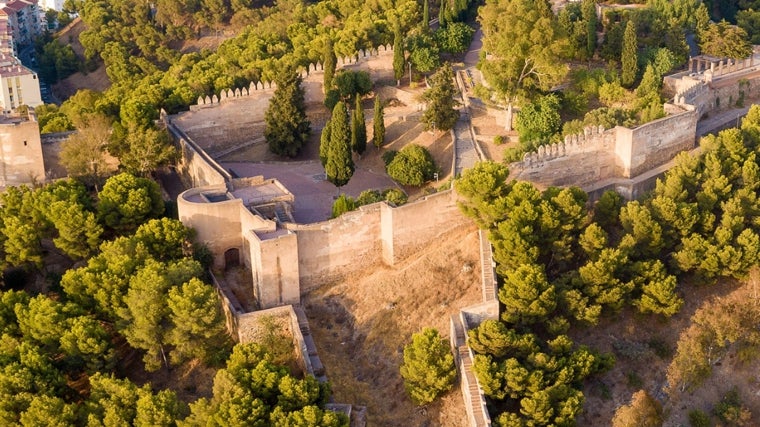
[325,101,354,187]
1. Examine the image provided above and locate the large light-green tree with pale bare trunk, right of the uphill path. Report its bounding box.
[478,0,568,130]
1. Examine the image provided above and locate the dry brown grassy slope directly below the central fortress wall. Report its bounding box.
[302,226,481,426]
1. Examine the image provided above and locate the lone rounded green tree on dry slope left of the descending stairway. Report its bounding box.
[401,328,457,405]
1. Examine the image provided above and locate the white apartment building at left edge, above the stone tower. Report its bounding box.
[0,54,43,114]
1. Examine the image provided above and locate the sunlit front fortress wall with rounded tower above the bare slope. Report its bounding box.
[177,177,469,308]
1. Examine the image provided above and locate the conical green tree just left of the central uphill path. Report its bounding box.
[420,63,459,131]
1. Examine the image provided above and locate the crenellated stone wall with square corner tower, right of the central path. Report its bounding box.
[510,53,760,198]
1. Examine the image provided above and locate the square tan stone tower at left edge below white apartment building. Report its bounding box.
[0,109,45,187]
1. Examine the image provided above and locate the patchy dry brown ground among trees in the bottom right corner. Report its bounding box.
[571,282,760,427]
